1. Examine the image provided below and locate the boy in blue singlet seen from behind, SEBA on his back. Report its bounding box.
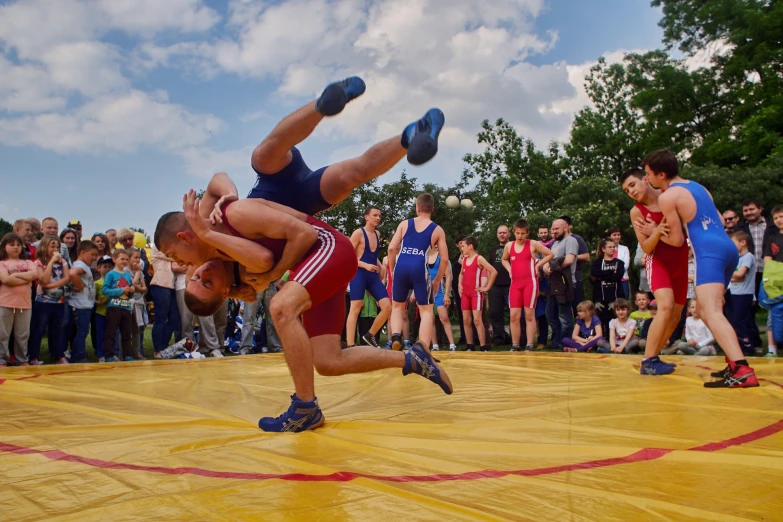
[389,194,449,350]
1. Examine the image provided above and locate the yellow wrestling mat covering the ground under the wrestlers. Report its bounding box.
[0,352,783,521]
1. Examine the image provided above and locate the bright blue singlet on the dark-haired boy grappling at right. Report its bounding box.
[669,181,739,287]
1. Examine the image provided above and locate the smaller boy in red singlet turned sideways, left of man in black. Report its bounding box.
[459,236,498,352]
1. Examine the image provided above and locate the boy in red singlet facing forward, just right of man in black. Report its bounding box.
[501,219,555,352]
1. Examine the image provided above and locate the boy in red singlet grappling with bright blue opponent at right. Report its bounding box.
[620,168,688,375]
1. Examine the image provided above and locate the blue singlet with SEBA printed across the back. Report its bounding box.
[392,218,438,305]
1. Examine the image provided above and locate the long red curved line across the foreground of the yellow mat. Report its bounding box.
[0,420,783,482]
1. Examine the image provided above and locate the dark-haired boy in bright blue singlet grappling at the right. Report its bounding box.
[642,149,759,388]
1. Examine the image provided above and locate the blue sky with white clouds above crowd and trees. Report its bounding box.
[0,0,662,240]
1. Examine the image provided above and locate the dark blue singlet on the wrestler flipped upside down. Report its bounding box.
[247,147,332,216]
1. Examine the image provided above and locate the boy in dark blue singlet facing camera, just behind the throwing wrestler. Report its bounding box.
[345,206,391,348]
